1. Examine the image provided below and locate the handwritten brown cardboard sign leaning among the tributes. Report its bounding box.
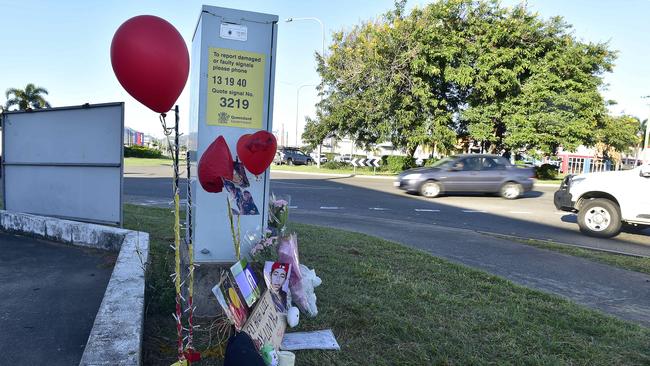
[242,290,287,351]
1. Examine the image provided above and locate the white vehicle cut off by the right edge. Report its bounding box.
[554,163,650,238]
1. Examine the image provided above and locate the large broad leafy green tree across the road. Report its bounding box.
[318,0,615,154]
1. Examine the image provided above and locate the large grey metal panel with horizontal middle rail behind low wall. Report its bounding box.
[2,103,124,225]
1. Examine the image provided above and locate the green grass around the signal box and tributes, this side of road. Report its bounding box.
[125,205,650,365]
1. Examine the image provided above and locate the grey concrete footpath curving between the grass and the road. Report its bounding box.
[291,210,650,326]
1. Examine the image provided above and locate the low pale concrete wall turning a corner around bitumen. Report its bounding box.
[0,210,149,365]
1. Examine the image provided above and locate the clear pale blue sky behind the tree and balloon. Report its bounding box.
[0,0,650,143]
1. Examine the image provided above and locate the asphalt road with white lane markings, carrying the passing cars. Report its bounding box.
[124,167,650,257]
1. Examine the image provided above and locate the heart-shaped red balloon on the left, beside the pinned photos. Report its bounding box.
[198,136,234,193]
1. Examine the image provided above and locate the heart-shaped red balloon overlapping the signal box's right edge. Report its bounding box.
[237,131,278,175]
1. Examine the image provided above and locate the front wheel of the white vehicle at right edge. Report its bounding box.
[578,198,621,238]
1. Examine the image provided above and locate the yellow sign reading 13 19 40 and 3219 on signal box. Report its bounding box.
[206,47,266,129]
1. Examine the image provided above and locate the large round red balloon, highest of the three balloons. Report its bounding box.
[111,15,190,113]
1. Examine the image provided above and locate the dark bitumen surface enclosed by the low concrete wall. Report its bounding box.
[0,232,115,366]
